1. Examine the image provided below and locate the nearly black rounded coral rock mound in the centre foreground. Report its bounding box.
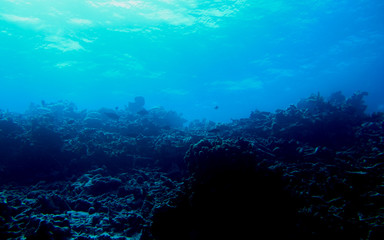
[152,140,300,239]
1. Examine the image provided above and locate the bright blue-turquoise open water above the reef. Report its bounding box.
[0,0,384,121]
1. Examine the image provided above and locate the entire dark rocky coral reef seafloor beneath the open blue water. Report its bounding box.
[0,92,384,240]
